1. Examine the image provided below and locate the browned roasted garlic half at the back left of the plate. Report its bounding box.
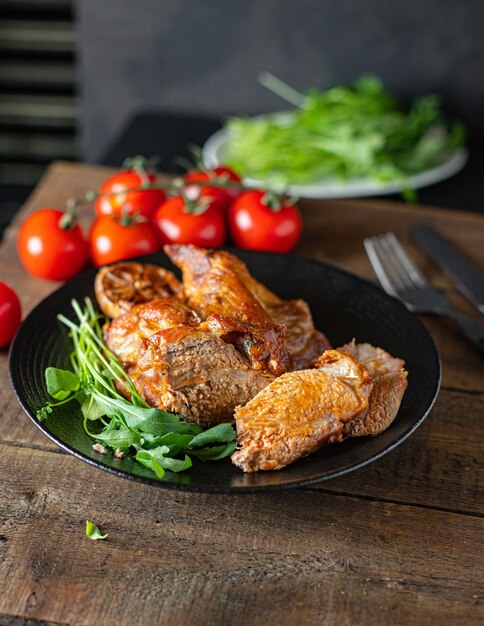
[94,261,185,318]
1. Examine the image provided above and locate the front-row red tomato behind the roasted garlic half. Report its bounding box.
[89,215,160,267]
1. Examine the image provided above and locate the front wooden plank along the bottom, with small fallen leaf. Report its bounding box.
[0,446,484,626]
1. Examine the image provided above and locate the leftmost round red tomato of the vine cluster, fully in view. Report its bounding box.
[17,208,87,280]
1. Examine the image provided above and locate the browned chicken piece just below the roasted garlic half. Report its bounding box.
[103,297,200,368]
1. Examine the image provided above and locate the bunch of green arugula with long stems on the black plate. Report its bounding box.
[37,298,236,478]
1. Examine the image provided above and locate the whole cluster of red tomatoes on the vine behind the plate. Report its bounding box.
[18,158,302,280]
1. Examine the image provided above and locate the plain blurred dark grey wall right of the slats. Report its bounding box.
[76,0,484,161]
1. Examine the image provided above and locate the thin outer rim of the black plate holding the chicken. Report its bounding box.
[8,247,442,494]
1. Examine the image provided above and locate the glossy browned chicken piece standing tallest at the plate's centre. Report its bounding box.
[164,245,289,376]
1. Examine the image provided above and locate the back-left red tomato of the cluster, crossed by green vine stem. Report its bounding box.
[94,169,166,219]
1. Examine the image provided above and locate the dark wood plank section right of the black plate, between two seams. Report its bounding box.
[317,390,484,513]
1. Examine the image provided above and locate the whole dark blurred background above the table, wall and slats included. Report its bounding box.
[0,0,484,229]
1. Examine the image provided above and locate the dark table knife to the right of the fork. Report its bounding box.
[414,224,484,313]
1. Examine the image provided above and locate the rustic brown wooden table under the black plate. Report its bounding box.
[0,163,484,626]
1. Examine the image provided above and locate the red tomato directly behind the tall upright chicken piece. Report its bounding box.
[153,196,225,248]
